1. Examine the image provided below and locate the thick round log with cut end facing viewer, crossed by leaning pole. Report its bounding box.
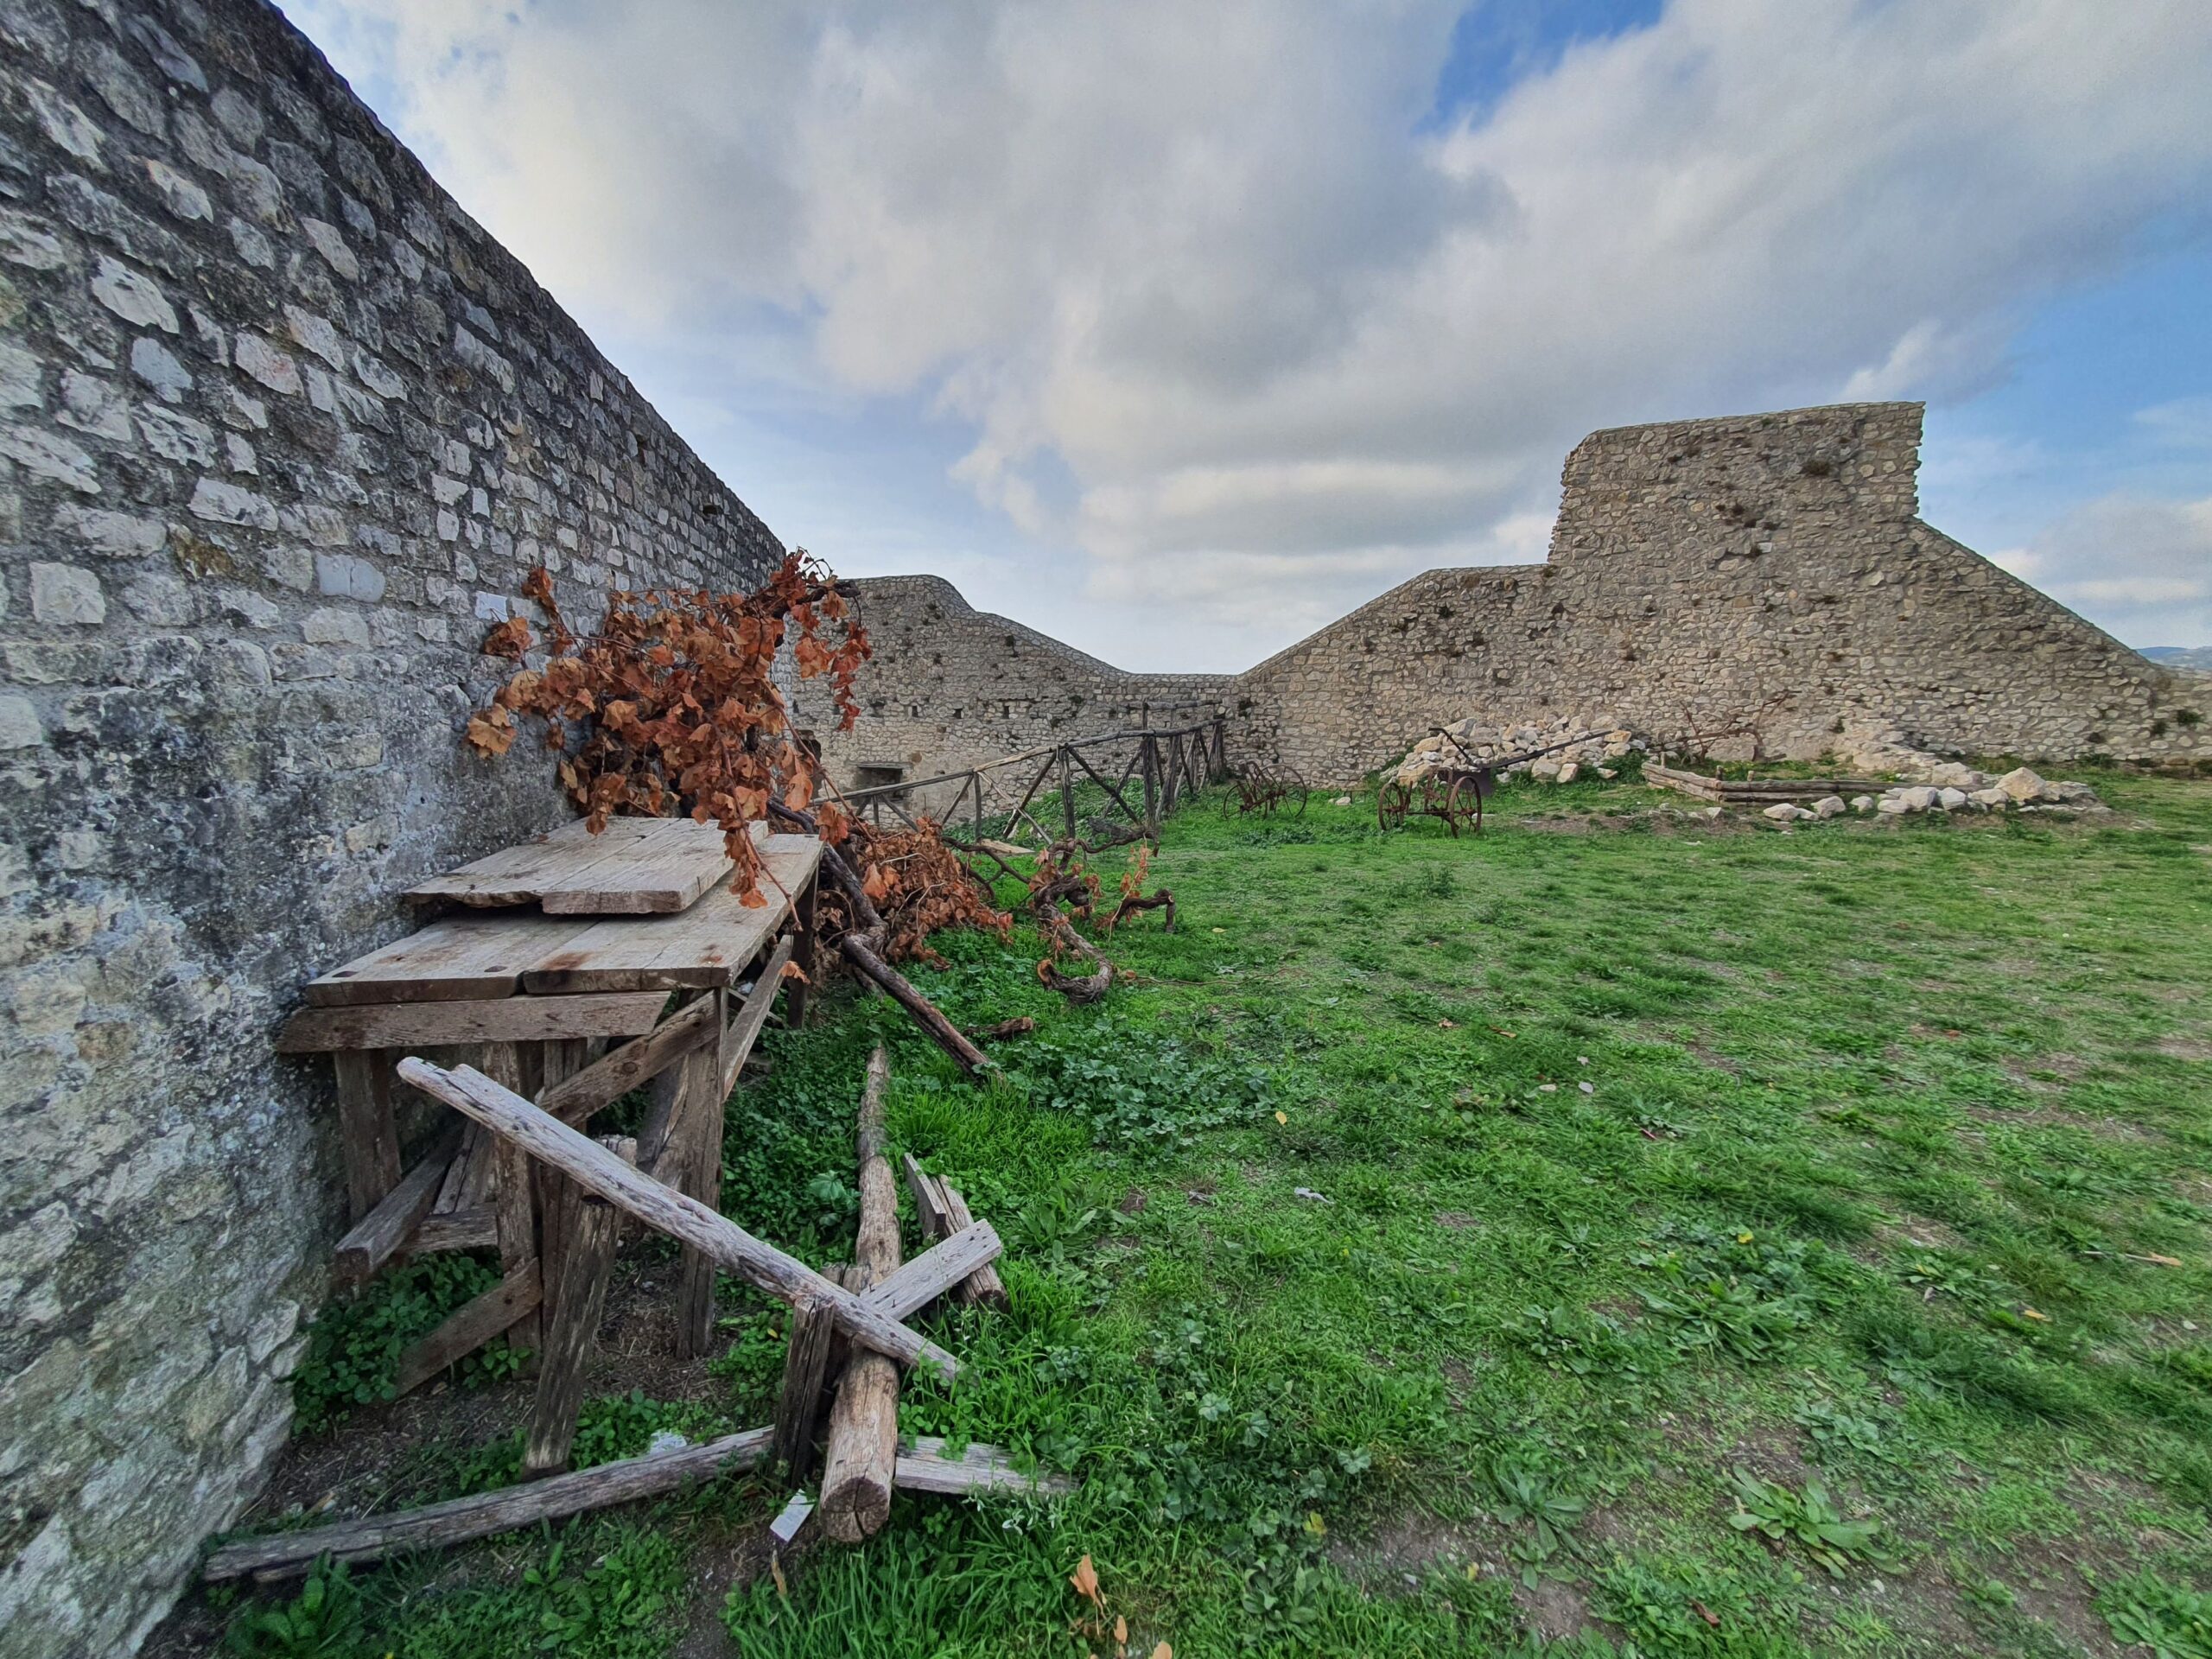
[817,1046,898,1544]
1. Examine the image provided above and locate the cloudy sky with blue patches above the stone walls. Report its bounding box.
[283,0,2212,668]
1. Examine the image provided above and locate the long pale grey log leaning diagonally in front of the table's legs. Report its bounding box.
[398,1058,960,1376]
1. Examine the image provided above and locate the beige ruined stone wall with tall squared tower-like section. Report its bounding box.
[836,403,2212,783]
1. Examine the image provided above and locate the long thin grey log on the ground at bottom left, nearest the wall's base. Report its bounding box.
[206,1429,770,1584]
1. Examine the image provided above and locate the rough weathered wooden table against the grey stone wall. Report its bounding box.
[276,818,823,1473]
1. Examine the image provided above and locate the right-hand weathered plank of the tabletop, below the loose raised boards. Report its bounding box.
[522,836,823,995]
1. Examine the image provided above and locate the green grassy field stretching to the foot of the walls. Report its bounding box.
[199,777,2212,1659]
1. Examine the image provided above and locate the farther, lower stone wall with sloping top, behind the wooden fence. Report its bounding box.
[797,575,1230,810]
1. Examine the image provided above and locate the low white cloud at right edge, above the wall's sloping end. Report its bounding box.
[1993,493,2212,646]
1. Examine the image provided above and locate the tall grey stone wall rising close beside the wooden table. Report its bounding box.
[0,0,781,1659]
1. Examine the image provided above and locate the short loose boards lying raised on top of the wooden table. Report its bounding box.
[404,818,730,916]
